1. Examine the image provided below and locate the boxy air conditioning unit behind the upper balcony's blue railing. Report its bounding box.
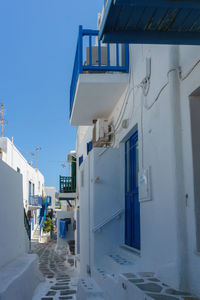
[86,46,108,66]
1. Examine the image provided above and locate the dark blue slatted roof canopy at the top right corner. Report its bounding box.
[99,0,200,45]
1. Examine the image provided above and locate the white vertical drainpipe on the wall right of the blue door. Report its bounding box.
[168,46,188,290]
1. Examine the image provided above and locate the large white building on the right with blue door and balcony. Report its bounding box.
[70,1,200,300]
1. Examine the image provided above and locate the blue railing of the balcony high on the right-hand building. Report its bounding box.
[70,26,129,116]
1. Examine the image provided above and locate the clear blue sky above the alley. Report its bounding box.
[0,0,103,187]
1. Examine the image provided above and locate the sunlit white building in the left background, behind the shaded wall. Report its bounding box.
[0,137,44,231]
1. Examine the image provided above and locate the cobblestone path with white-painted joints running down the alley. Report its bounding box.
[32,240,78,300]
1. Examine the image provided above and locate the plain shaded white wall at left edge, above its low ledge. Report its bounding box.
[0,160,27,268]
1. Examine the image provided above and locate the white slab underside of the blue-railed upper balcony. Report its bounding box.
[70,73,129,126]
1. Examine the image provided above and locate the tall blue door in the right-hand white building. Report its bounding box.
[125,132,140,250]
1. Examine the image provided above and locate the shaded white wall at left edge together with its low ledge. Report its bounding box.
[0,150,40,300]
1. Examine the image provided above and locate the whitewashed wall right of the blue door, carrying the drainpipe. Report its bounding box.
[77,45,200,294]
